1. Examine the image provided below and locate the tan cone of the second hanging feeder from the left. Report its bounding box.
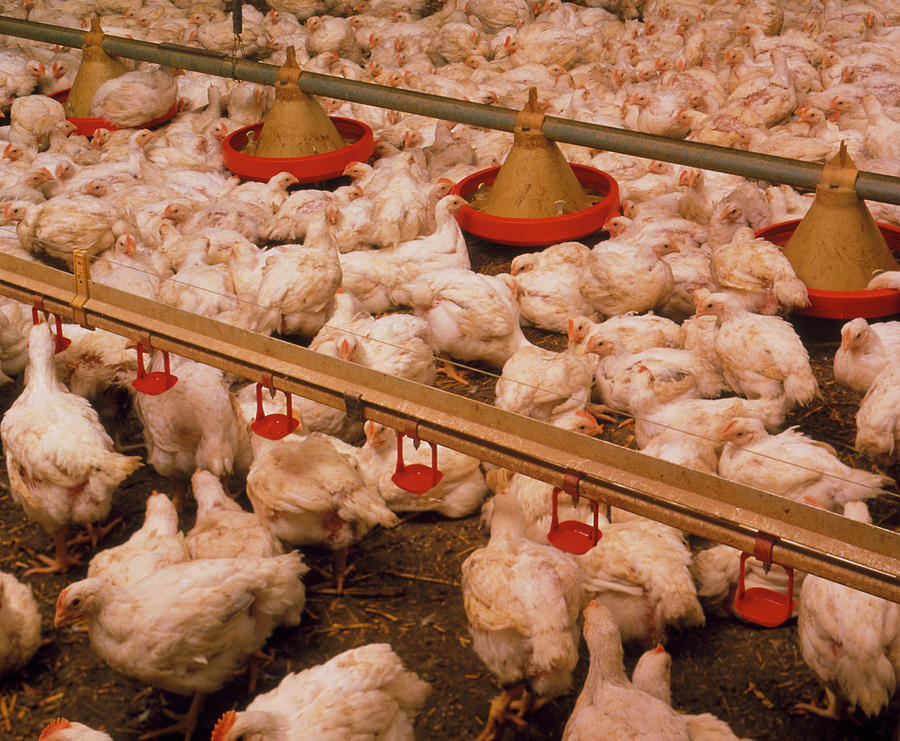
[253,46,346,157]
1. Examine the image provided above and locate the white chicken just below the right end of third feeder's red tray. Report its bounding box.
[581,239,675,316]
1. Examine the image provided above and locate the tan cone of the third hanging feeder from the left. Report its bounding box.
[481,88,591,219]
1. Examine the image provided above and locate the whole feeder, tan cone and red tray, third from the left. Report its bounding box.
[451,88,619,246]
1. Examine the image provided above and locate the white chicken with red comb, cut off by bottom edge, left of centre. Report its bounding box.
[211,643,431,741]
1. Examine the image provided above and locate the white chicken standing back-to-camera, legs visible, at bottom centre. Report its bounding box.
[462,494,584,739]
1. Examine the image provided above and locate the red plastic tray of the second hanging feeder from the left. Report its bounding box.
[222,116,375,183]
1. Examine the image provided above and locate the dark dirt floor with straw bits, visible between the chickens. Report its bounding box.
[0,227,897,741]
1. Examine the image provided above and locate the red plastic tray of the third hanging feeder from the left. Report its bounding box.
[450,164,619,247]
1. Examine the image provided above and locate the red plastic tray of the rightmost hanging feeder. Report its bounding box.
[756,219,900,319]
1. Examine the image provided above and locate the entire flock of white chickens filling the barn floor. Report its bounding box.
[0,0,900,741]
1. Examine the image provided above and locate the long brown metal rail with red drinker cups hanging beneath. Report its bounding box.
[0,253,900,602]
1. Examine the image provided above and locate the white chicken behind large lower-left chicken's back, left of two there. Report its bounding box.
[87,492,191,587]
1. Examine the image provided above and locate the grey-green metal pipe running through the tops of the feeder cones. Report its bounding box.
[0,16,900,204]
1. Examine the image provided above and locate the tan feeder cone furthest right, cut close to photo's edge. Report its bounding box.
[784,142,898,291]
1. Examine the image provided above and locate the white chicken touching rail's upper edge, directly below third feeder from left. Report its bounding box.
[494,342,596,422]
